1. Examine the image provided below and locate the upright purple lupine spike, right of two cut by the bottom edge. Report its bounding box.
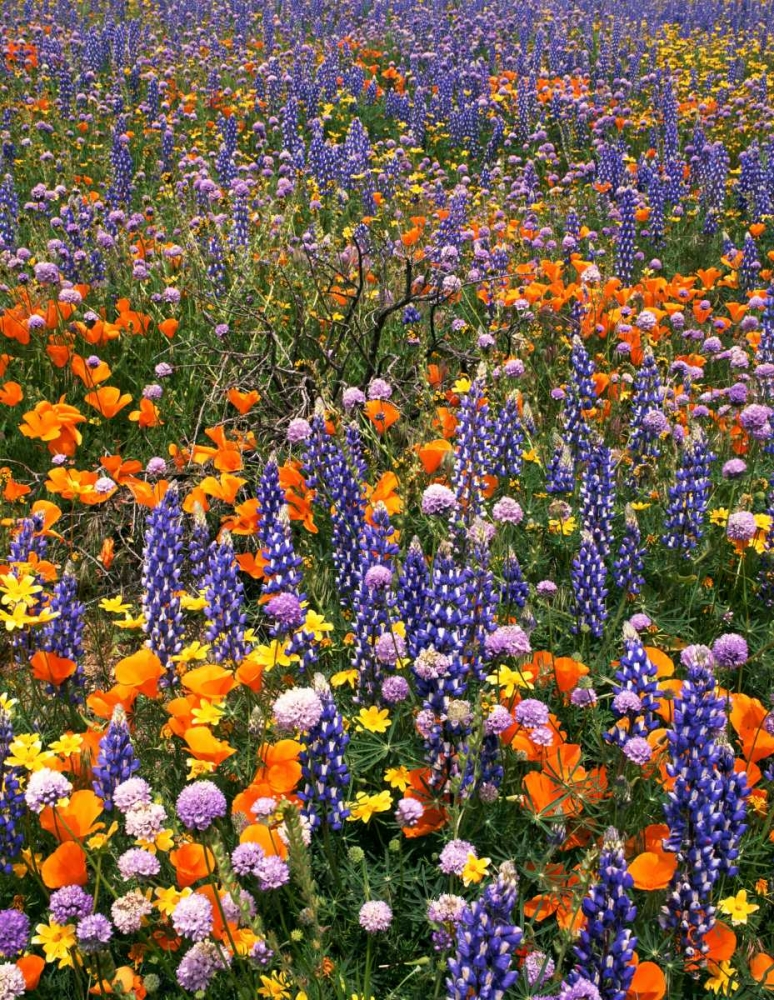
[568,829,637,1000]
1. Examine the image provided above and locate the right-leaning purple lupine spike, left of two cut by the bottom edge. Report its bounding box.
[446,862,522,1000]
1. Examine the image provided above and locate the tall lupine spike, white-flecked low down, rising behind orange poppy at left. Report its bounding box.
[142,484,185,687]
